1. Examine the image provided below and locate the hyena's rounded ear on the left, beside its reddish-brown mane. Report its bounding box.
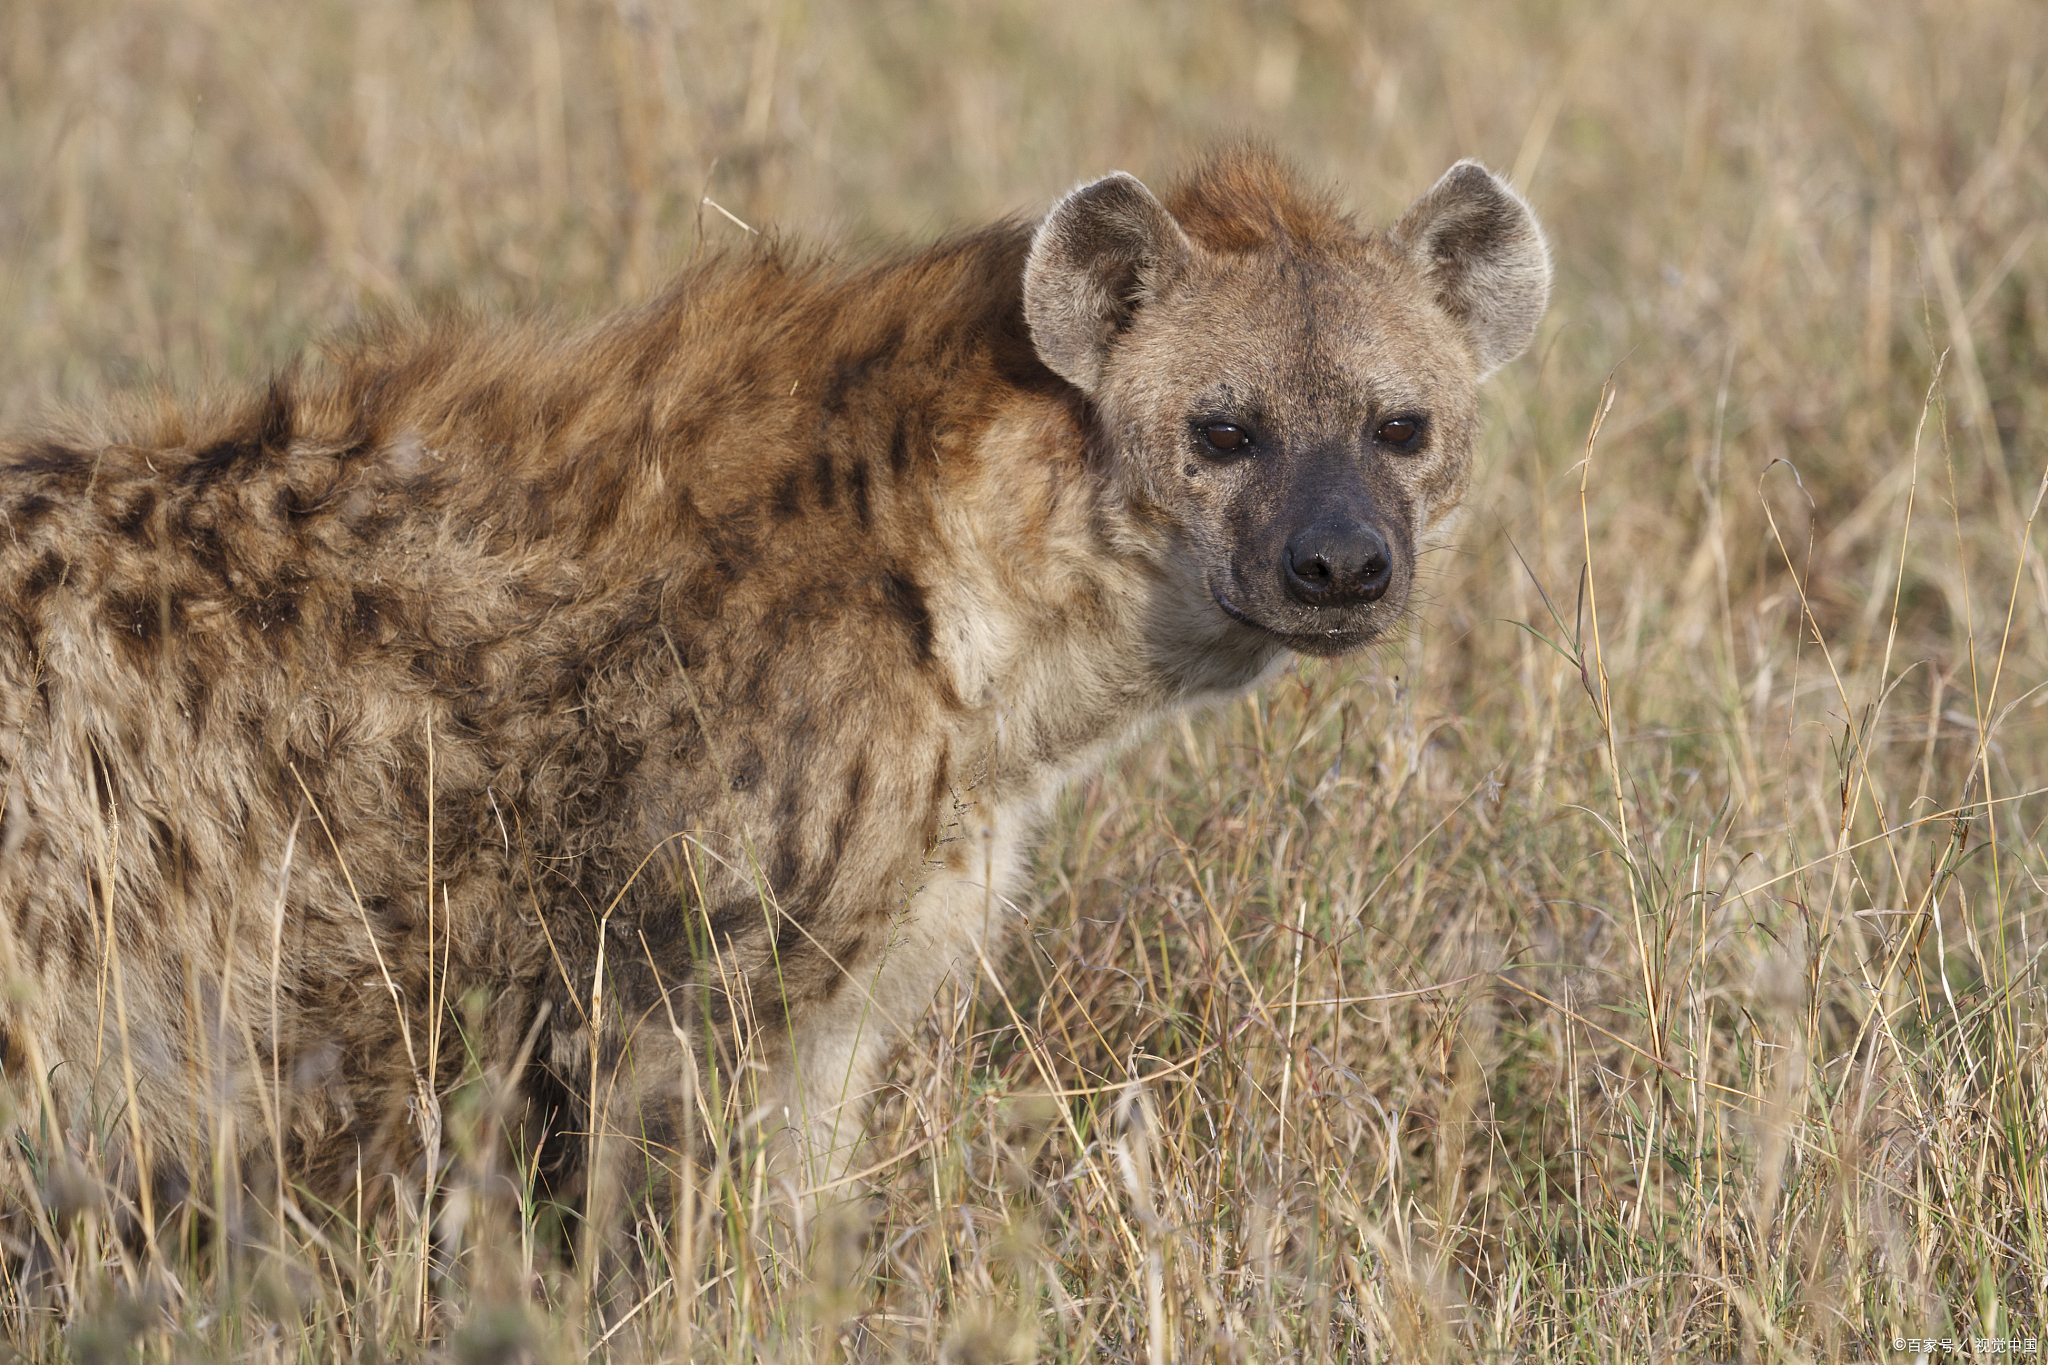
[1024,172,1192,395]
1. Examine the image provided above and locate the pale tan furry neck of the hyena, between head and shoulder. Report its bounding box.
[928,358,1286,822]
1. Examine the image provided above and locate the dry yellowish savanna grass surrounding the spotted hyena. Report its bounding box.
[0,0,2048,1363]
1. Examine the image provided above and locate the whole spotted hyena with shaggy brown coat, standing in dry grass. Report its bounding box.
[0,151,1550,1236]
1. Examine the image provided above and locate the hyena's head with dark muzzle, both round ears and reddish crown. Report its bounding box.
[1024,153,1550,655]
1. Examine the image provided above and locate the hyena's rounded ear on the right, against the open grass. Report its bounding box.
[1391,162,1550,379]
